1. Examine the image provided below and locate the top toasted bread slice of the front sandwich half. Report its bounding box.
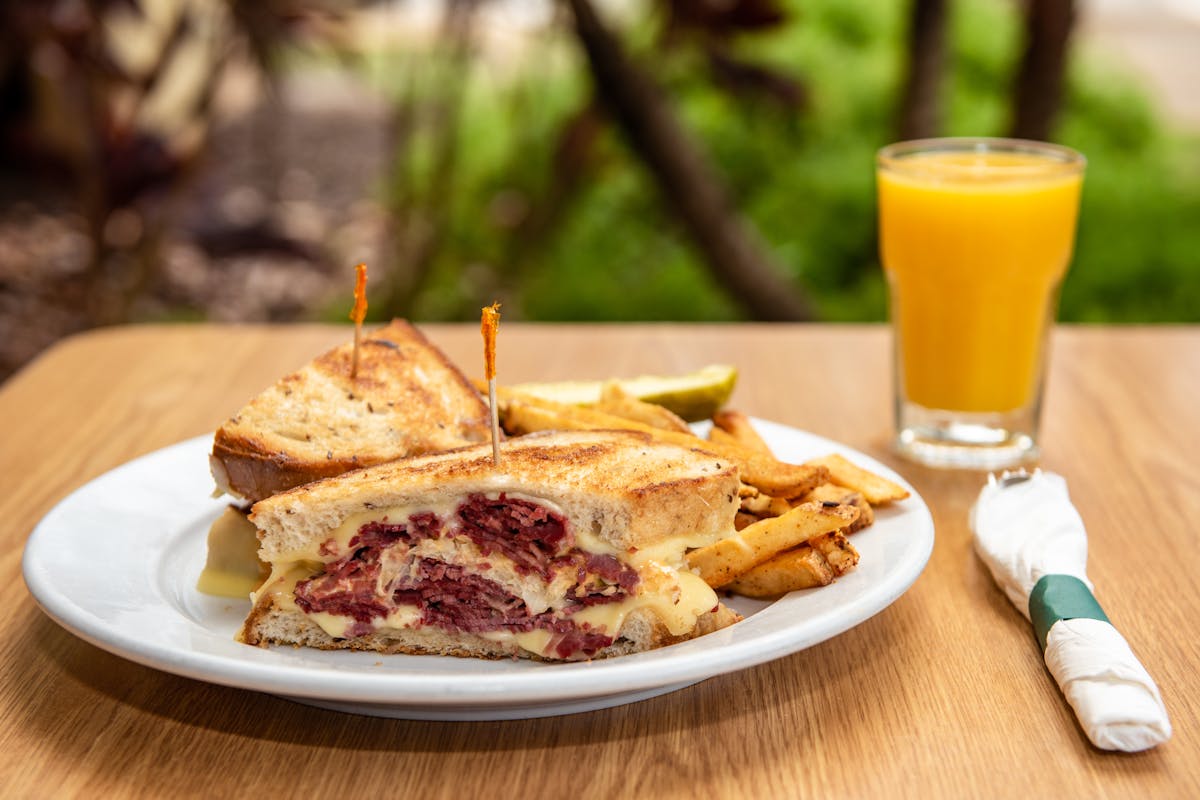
[251,431,739,561]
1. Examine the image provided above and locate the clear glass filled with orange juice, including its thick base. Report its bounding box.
[876,138,1085,469]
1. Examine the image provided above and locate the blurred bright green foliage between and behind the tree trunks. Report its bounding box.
[376,0,1200,321]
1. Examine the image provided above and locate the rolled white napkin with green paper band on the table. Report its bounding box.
[971,470,1171,752]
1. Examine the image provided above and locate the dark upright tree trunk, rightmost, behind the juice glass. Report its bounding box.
[1010,0,1075,140]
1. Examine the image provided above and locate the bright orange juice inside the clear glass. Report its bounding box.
[878,149,1082,413]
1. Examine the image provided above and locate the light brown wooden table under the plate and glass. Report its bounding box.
[0,324,1200,798]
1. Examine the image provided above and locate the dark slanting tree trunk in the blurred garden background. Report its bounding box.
[569,0,812,320]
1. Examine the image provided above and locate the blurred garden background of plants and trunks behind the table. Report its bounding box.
[0,0,1200,375]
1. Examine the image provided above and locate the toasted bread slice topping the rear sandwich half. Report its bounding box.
[210,320,491,503]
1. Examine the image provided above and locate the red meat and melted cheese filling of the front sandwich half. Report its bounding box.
[258,492,718,658]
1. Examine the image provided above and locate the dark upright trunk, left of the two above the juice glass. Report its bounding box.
[896,0,946,139]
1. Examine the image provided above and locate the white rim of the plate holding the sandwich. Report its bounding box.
[22,417,935,718]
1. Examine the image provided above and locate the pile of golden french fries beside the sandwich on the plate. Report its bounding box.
[497,381,908,597]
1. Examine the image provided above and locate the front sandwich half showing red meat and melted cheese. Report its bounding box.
[239,431,739,661]
